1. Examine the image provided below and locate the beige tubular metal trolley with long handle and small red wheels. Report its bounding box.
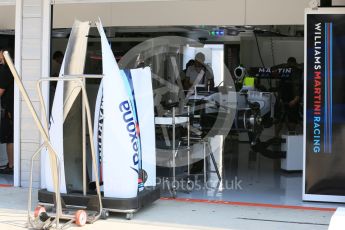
[4,51,104,229]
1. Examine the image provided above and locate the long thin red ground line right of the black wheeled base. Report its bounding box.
[160,198,336,212]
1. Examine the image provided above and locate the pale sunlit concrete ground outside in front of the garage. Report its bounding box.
[0,188,334,230]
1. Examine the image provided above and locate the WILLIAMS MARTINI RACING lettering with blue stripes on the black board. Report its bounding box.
[312,22,333,153]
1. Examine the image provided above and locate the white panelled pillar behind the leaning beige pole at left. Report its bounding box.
[14,0,49,187]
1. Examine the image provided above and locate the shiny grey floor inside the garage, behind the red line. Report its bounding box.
[161,133,338,208]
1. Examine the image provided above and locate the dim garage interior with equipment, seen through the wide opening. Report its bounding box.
[47,11,321,206]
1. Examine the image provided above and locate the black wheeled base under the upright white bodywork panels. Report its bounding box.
[38,187,160,220]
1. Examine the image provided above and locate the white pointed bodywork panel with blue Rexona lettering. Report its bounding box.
[96,21,138,198]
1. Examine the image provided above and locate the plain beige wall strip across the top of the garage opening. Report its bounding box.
[50,0,314,28]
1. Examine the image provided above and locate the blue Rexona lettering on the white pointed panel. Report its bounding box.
[119,101,139,165]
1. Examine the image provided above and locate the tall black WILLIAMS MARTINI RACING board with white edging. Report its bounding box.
[303,8,345,202]
